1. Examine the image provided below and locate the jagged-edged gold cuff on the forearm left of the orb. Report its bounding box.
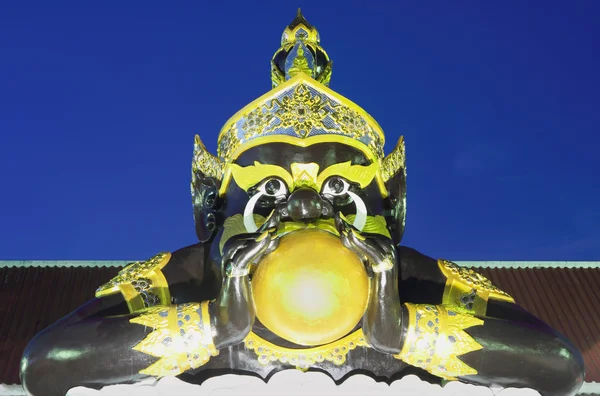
[130,301,219,377]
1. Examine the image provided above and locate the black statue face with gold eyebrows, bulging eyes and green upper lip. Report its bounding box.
[204,142,394,262]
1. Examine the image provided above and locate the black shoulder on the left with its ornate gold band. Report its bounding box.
[96,244,210,312]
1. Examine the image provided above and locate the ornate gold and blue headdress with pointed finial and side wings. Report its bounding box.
[193,10,405,189]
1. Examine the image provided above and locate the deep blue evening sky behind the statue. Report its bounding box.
[0,0,600,261]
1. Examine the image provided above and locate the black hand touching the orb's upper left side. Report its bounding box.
[223,211,280,277]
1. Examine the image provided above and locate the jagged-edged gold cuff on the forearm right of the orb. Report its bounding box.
[394,303,483,380]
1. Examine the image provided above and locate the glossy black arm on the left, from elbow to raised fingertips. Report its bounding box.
[21,215,276,396]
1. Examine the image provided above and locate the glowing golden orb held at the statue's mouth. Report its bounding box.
[252,229,369,345]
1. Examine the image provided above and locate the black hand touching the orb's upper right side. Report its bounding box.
[335,212,396,273]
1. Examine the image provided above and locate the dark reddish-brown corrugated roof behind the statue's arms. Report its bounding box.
[0,266,600,384]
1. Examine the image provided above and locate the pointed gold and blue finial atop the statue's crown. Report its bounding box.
[271,8,332,88]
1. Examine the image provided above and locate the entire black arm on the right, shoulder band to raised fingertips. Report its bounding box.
[338,217,584,395]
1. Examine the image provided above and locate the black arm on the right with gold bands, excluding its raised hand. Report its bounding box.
[397,260,584,395]
